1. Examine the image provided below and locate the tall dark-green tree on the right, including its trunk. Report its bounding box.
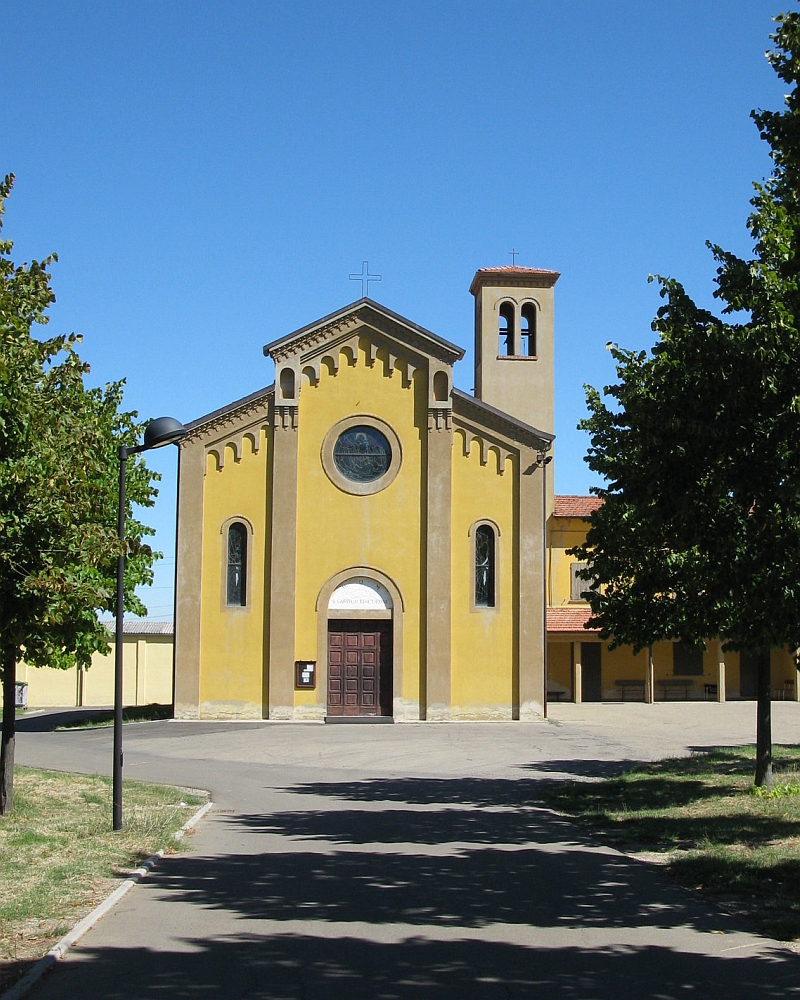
[575,13,800,787]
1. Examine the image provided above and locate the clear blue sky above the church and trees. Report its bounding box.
[0,0,791,618]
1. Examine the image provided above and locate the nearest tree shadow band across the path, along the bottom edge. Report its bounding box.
[28,933,800,1000]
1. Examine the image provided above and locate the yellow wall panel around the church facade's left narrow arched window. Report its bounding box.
[200,429,270,719]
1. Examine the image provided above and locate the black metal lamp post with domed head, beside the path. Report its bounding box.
[112,417,186,830]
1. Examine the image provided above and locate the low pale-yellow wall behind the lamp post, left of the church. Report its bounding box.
[9,635,173,709]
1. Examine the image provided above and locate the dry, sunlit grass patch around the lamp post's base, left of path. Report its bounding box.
[0,767,206,993]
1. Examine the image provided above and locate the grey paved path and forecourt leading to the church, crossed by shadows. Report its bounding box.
[9,703,800,1000]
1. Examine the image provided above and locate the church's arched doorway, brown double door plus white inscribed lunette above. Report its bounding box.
[326,576,393,716]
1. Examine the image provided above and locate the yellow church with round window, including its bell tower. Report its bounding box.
[175,267,558,722]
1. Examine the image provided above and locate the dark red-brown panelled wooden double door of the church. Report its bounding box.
[328,619,392,716]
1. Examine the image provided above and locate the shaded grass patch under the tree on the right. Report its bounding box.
[543,746,800,941]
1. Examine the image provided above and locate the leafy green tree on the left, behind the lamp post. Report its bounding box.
[0,175,156,814]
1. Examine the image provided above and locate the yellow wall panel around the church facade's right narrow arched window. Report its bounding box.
[450,430,518,719]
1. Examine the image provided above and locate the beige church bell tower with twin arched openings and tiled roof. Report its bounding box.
[469,267,559,434]
